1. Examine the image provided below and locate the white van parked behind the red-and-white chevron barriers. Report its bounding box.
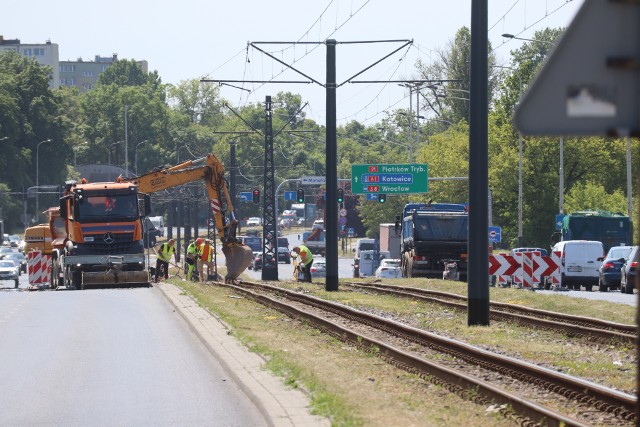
[553,240,605,291]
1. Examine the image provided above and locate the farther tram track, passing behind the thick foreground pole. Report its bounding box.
[345,282,637,344]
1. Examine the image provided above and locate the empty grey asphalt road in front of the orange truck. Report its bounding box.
[0,284,266,426]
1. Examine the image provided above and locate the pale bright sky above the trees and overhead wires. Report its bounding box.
[0,0,584,125]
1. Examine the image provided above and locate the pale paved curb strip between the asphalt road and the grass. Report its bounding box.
[154,282,331,427]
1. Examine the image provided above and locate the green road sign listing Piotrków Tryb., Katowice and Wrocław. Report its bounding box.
[351,164,429,194]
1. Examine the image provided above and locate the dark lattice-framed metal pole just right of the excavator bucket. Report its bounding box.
[262,95,278,280]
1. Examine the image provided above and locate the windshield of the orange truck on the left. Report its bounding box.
[76,194,138,221]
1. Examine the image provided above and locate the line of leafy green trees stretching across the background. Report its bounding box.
[0,27,640,247]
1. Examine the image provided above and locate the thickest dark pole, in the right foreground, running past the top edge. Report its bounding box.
[467,0,489,326]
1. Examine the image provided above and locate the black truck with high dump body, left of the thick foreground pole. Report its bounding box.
[396,203,469,281]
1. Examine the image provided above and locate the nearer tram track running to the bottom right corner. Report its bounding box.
[214,282,636,425]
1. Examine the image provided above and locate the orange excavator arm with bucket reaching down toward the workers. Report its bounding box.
[128,154,253,281]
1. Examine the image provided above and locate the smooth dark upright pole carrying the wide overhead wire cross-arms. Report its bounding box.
[325,39,338,291]
